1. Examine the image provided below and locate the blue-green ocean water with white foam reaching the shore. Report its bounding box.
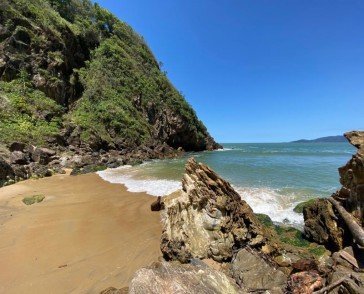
[98,142,356,227]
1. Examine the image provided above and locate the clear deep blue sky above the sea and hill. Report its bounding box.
[97,0,364,143]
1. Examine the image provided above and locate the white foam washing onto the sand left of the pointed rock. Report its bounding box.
[97,165,182,196]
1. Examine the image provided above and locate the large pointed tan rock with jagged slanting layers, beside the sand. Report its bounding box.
[161,158,264,262]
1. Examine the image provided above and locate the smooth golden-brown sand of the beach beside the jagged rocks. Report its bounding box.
[0,174,161,293]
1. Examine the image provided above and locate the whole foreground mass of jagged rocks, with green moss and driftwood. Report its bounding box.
[103,132,364,293]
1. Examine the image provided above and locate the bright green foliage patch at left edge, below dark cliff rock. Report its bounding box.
[0,80,63,144]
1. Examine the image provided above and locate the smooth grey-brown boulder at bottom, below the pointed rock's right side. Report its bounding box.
[231,248,287,293]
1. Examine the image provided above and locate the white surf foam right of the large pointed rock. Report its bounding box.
[234,187,303,227]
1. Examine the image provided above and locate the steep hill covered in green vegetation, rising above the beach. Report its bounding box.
[0,0,218,151]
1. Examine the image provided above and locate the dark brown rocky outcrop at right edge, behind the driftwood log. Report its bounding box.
[303,131,364,251]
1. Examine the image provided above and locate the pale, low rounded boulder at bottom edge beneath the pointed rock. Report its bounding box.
[129,261,242,294]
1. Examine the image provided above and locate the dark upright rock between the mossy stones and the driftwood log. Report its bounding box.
[303,199,348,251]
